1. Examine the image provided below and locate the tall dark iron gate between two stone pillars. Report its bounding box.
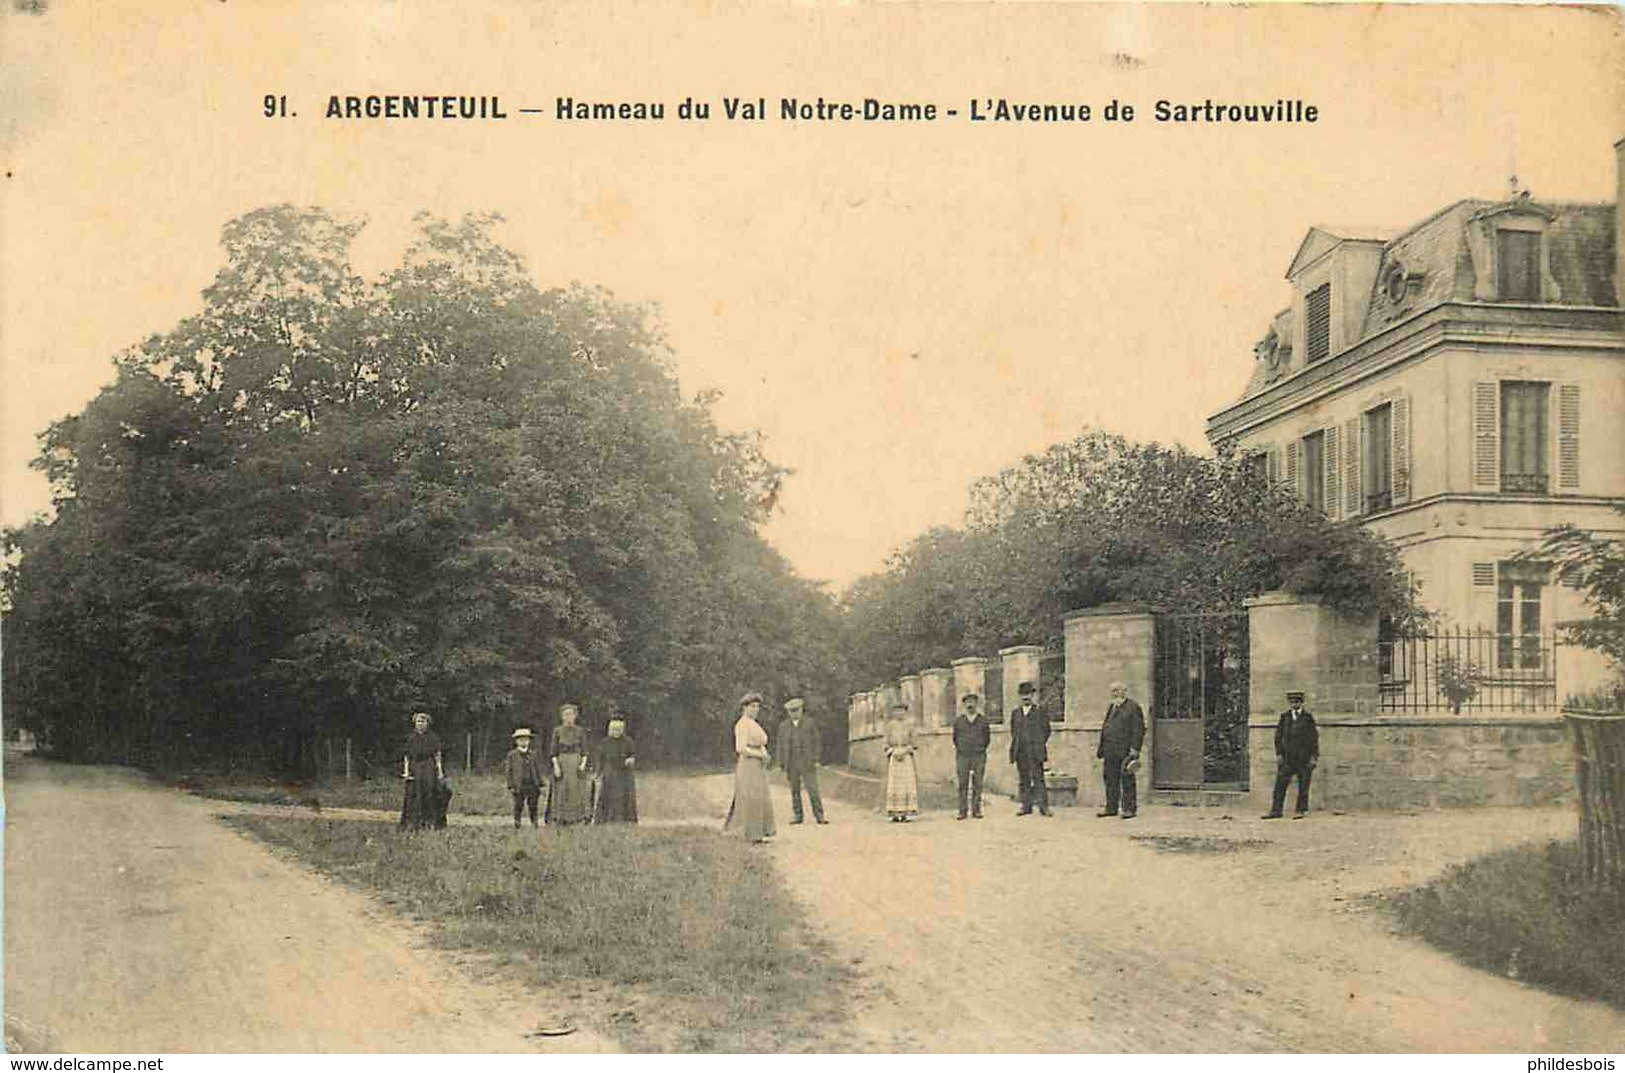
[1151,611,1248,788]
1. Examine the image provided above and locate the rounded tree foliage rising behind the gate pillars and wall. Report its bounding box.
[843,431,1419,684]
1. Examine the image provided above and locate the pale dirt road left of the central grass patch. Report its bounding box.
[5,758,613,1053]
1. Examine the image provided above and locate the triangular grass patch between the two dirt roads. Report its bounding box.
[228,816,848,1052]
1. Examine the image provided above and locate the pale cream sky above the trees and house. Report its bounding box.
[0,0,1625,587]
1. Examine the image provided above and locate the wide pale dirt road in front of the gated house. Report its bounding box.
[770,773,1625,1052]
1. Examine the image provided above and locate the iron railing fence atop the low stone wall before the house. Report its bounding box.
[1376,629,1558,714]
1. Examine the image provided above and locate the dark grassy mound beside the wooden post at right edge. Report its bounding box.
[1389,842,1625,1008]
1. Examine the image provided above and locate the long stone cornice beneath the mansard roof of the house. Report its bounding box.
[1207,302,1625,444]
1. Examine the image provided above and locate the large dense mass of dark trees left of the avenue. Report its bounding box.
[5,205,839,771]
